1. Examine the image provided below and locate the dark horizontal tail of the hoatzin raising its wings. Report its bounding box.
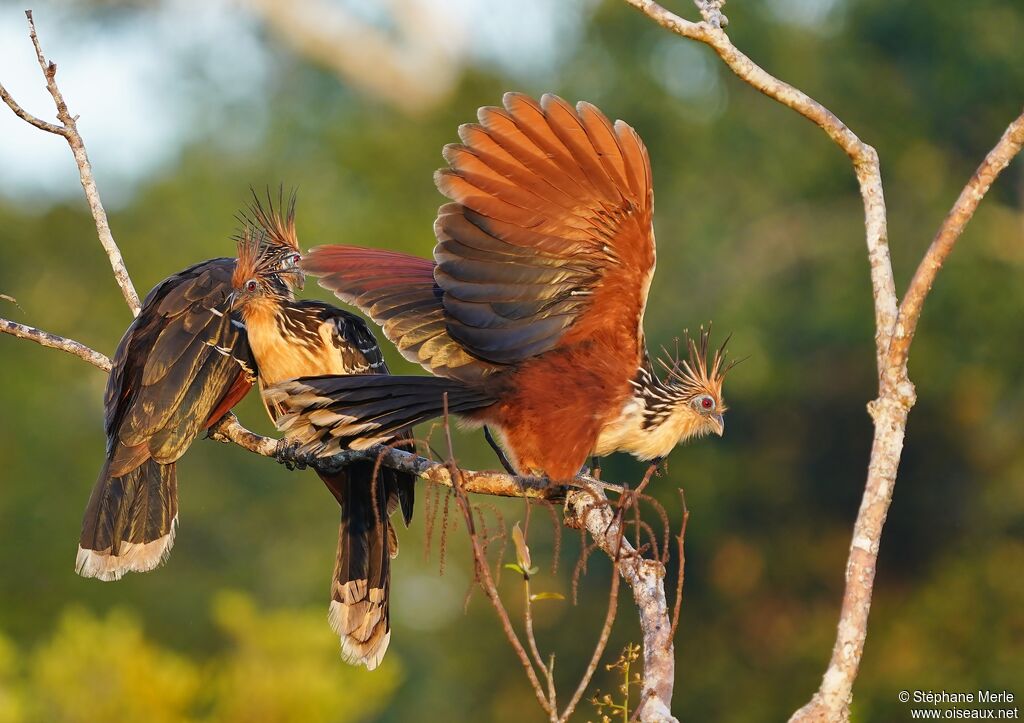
[263,375,495,457]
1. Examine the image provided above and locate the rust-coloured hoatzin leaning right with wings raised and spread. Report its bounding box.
[267,93,729,480]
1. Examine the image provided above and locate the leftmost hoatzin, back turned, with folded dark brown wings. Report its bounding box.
[76,194,303,581]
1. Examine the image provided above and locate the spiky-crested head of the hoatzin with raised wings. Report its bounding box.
[658,326,737,441]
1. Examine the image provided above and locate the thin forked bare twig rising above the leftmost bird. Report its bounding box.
[0,10,141,316]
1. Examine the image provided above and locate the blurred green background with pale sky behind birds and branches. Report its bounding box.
[0,0,1024,723]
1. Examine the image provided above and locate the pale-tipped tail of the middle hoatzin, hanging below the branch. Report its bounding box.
[321,462,413,670]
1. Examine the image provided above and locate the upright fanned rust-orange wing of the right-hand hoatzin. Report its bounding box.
[434,93,654,364]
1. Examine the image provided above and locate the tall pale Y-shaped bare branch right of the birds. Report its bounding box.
[626,0,1024,721]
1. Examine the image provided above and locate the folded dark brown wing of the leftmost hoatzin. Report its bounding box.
[104,258,253,466]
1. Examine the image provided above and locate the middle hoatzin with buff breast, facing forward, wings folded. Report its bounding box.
[232,221,416,670]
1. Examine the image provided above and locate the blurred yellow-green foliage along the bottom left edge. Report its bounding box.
[0,592,401,723]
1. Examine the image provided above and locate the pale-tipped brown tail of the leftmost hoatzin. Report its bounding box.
[75,459,178,581]
